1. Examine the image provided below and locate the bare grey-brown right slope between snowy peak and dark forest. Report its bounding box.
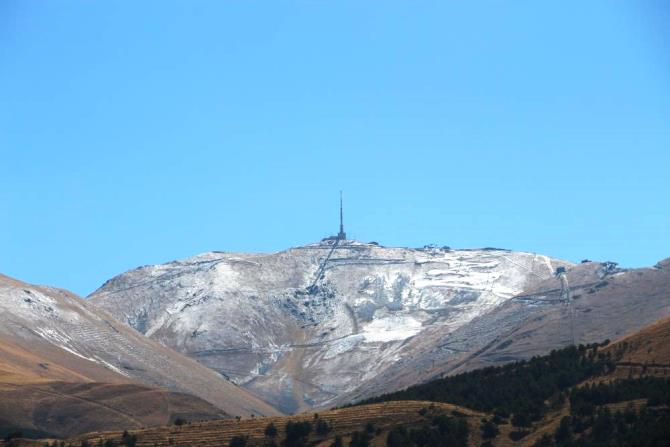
[338,260,670,404]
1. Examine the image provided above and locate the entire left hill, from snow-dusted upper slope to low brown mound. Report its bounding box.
[0,275,277,436]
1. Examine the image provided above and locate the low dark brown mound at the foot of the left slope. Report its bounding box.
[0,382,226,437]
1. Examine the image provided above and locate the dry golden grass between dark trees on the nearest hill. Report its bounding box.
[9,319,670,447]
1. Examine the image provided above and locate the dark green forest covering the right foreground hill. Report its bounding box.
[362,343,670,447]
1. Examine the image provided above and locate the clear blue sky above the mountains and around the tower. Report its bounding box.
[0,0,670,295]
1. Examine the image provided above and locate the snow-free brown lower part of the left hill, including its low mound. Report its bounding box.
[0,340,227,437]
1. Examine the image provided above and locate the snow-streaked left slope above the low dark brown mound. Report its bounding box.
[0,275,278,416]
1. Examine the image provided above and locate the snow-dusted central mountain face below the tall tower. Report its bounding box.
[90,240,571,412]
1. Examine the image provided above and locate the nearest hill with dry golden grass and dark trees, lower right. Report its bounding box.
[52,319,670,447]
